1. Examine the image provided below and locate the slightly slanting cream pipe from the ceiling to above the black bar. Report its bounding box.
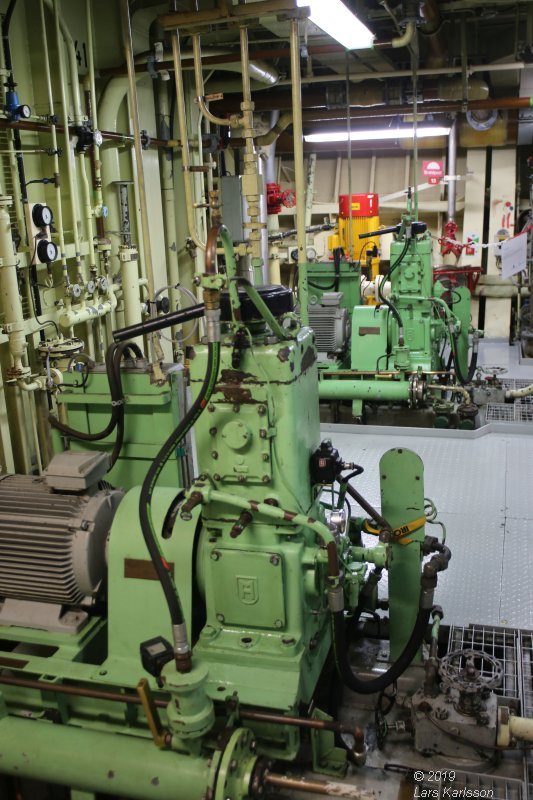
[120,0,155,298]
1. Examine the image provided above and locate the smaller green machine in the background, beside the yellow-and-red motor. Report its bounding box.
[320,203,479,419]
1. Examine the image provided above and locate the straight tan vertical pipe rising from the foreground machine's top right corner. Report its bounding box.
[290,19,309,325]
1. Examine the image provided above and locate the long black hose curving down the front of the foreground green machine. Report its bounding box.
[139,342,220,625]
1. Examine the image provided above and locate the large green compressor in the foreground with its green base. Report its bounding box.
[0,250,449,800]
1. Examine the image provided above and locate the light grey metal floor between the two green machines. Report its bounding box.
[323,342,533,629]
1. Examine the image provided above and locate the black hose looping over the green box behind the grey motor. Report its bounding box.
[48,342,143,467]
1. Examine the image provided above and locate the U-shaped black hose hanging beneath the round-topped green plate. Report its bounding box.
[331,608,431,694]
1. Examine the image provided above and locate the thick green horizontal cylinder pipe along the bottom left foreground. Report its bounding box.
[0,716,210,800]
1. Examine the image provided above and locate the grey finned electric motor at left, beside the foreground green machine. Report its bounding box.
[0,453,123,604]
